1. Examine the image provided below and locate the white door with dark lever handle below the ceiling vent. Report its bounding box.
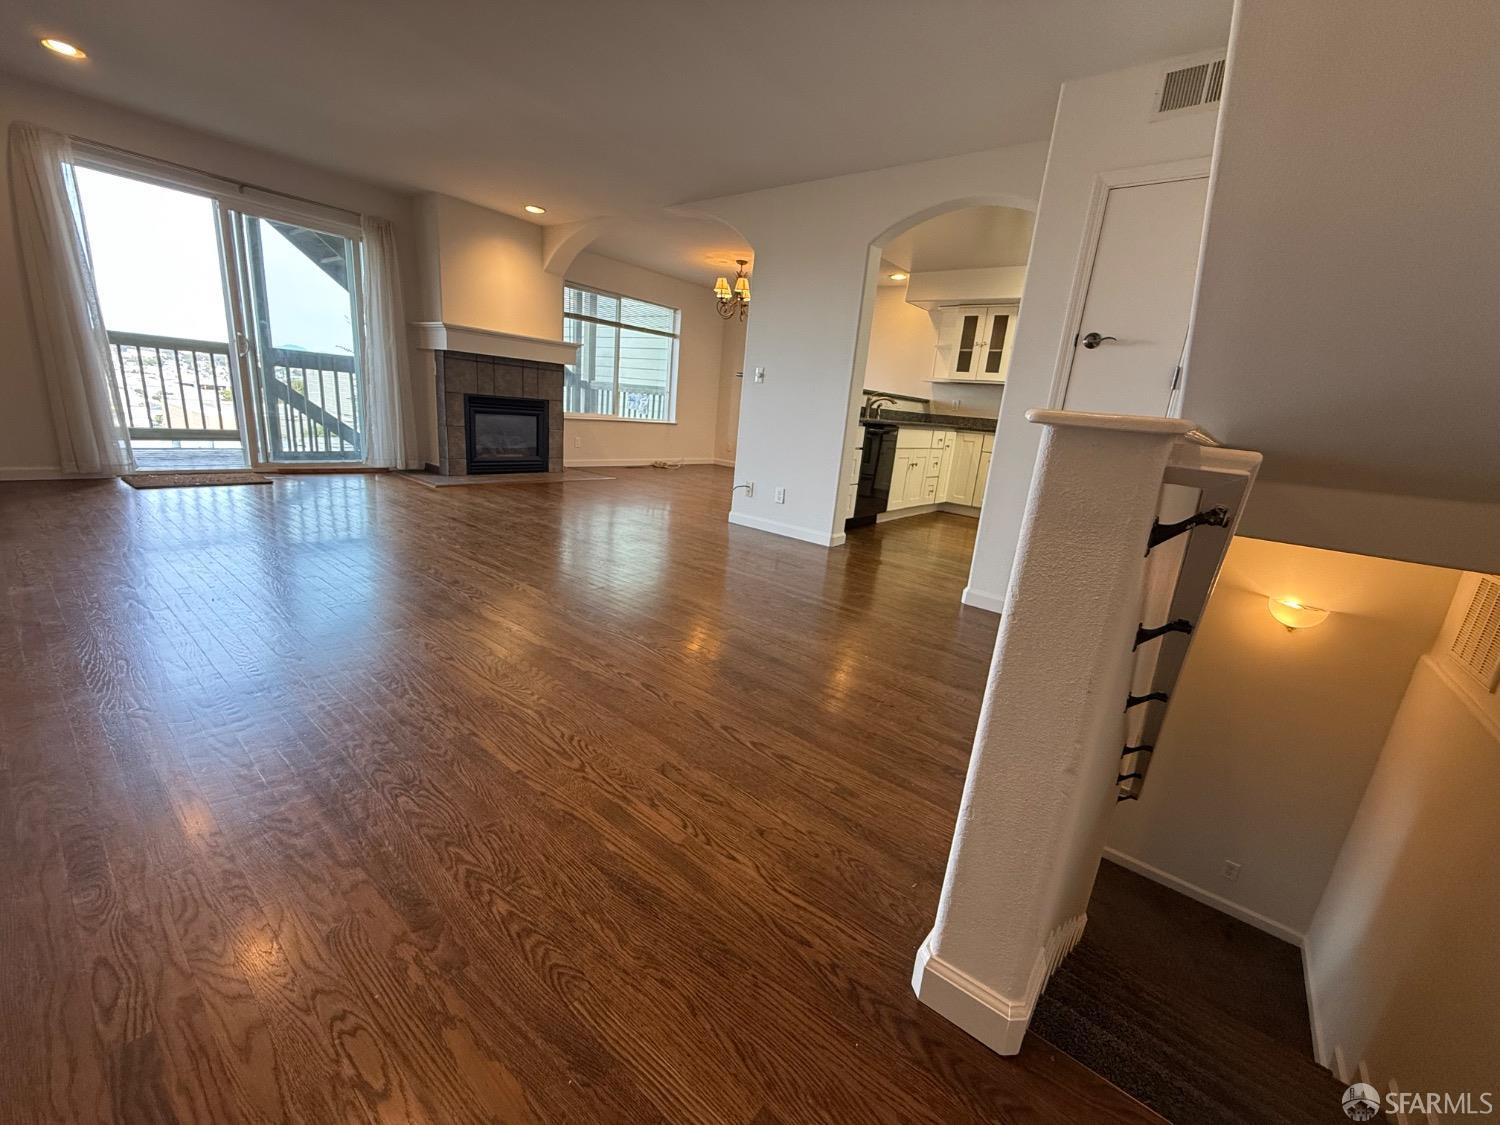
[1062,177,1209,416]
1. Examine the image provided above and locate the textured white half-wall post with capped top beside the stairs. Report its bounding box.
[912,411,1194,1055]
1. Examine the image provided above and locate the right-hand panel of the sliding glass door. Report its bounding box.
[233,212,366,462]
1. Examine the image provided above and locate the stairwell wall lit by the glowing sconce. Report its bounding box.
[1109,537,1458,941]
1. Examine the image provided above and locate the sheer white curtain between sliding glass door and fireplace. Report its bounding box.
[360,216,422,470]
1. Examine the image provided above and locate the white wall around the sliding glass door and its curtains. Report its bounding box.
[0,77,423,476]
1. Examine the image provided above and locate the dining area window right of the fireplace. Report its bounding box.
[563,282,681,422]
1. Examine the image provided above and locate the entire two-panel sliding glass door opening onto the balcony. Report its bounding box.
[75,158,368,470]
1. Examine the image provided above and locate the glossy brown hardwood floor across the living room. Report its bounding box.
[0,468,1157,1125]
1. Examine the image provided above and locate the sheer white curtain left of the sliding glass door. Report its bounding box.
[11,123,134,473]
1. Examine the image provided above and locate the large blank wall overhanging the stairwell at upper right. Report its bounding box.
[1176,0,1500,582]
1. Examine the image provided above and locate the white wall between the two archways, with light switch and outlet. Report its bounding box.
[695,144,1044,543]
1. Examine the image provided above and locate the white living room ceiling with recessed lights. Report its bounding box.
[0,0,1232,276]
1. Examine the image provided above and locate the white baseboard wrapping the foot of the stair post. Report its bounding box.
[912,914,1088,1055]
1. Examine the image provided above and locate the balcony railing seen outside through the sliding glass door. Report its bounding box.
[110,332,365,461]
